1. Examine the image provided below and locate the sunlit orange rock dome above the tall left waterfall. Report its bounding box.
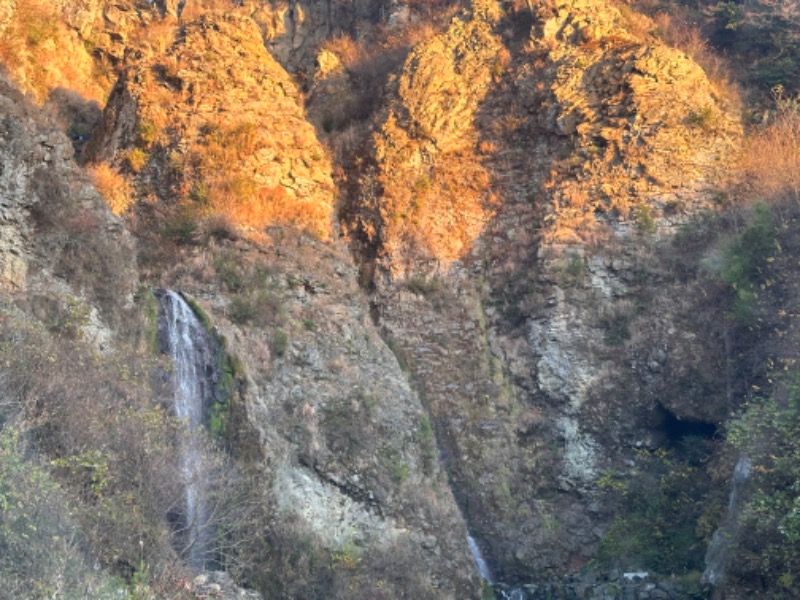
[87,15,333,237]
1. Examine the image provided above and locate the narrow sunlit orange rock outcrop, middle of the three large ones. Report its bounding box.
[358,2,502,270]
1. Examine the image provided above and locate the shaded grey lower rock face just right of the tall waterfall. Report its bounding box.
[159,231,477,598]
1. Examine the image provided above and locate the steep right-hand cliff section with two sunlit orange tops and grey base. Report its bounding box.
[344,2,741,580]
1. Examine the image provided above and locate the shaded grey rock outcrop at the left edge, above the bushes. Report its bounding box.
[0,74,136,322]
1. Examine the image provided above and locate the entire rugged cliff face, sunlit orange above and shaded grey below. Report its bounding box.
[0,0,791,598]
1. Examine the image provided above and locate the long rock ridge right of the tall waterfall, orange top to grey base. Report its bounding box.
[79,7,478,598]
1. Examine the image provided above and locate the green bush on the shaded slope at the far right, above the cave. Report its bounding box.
[720,203,780,325]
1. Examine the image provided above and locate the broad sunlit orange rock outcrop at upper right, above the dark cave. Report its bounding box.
[515,2,742,243]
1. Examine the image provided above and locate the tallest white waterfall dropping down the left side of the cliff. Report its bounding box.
[159,290,216,570]
